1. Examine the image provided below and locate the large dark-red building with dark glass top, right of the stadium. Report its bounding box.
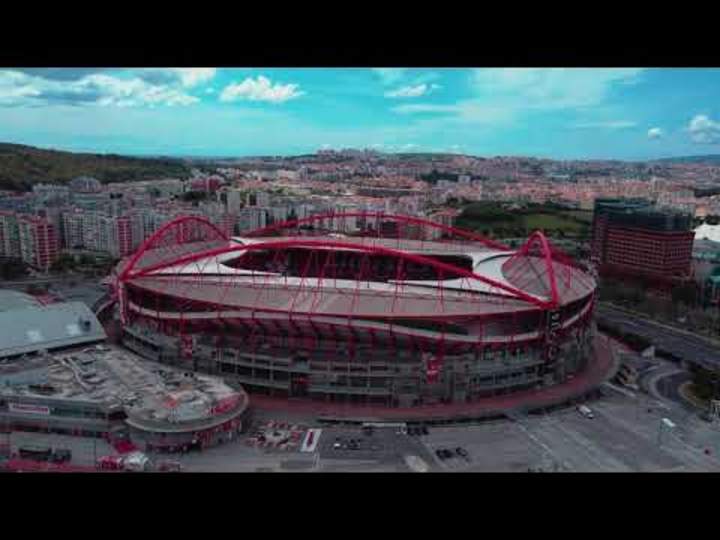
[592,199,695,283]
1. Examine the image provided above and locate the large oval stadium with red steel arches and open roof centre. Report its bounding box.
[115,212,596,407]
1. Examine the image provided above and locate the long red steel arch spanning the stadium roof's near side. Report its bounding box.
[120,239,556,309]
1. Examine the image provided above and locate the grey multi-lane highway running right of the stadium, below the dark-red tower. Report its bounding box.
[596,305,720,367]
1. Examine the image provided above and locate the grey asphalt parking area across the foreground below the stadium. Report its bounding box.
[8,386,720,473]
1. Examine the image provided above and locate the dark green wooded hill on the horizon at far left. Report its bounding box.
[0,143,190,191]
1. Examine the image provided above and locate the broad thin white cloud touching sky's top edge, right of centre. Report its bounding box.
[472,68,643,109]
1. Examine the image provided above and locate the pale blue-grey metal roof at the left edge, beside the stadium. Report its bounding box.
[0,302,107,358]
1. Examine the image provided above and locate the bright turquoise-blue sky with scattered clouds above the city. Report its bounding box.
[0,68,720,160]
